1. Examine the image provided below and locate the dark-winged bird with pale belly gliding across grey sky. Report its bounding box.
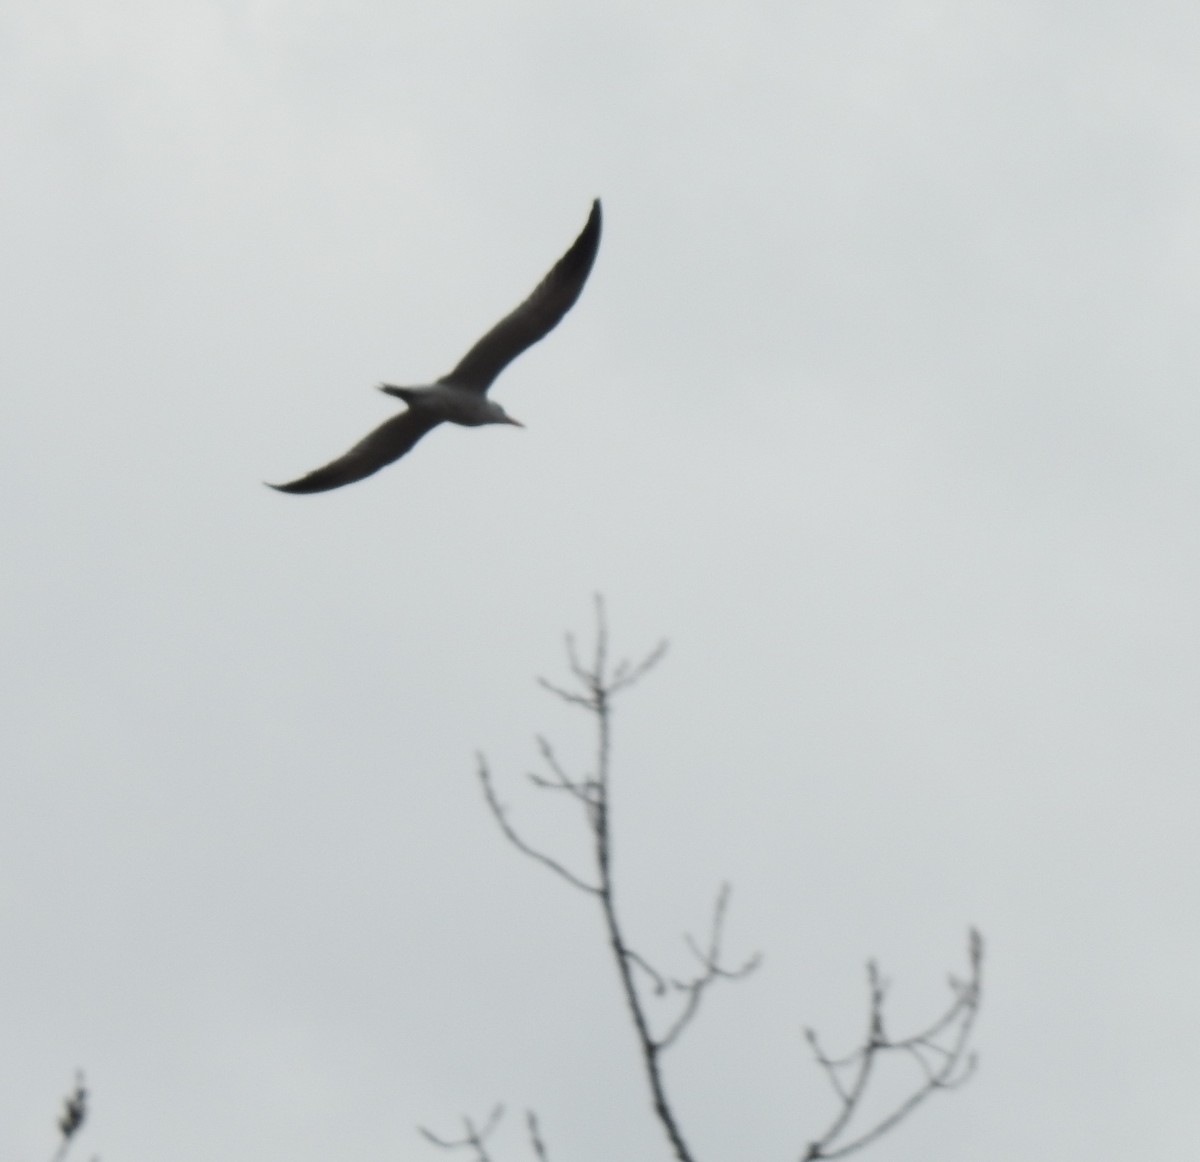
[271,199,600,492]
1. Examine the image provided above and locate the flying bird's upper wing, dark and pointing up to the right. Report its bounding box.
[438,198,600,394]
